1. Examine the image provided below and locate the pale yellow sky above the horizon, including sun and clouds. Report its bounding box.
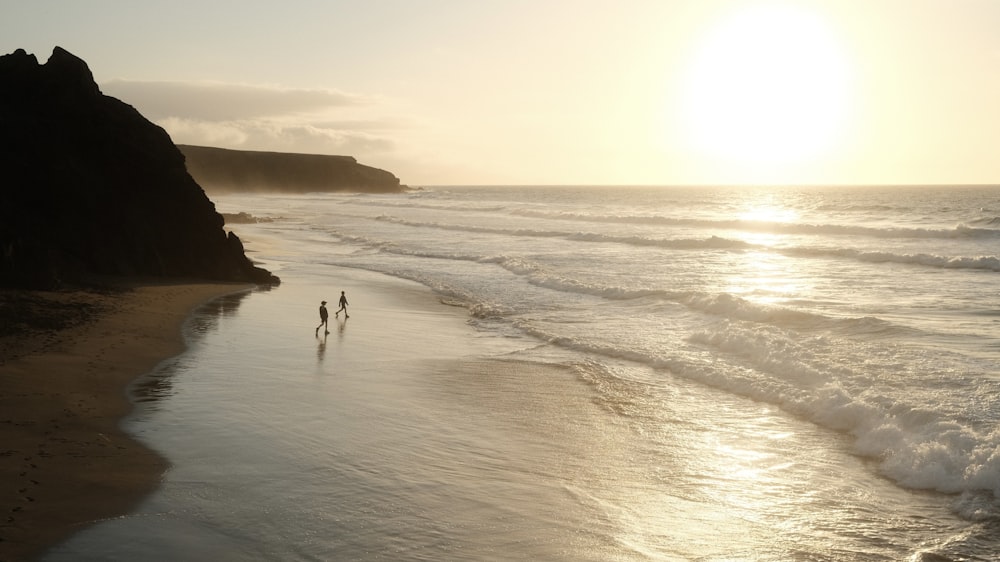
[0,0,1000,186]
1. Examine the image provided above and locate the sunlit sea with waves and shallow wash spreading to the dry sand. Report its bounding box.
[45,186,1000,562]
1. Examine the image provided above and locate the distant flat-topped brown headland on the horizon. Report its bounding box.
[178,145,405,193]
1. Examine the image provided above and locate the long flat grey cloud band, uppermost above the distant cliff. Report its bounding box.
[101,80,374,121]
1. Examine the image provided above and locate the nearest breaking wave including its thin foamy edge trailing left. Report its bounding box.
[548,326,1000,521]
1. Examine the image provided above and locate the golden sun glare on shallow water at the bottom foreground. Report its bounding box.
[602,407,824,562]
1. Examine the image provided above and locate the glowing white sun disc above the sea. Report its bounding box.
[682,6,851,174]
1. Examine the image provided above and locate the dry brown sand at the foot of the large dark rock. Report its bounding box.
[0,281,252,562]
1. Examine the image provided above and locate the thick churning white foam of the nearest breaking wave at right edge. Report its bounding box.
[681,326,1000,518]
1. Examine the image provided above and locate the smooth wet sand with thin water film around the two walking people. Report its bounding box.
[41,260,630,562]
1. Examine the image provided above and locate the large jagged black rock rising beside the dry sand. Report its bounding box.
[0,47,277,288]
